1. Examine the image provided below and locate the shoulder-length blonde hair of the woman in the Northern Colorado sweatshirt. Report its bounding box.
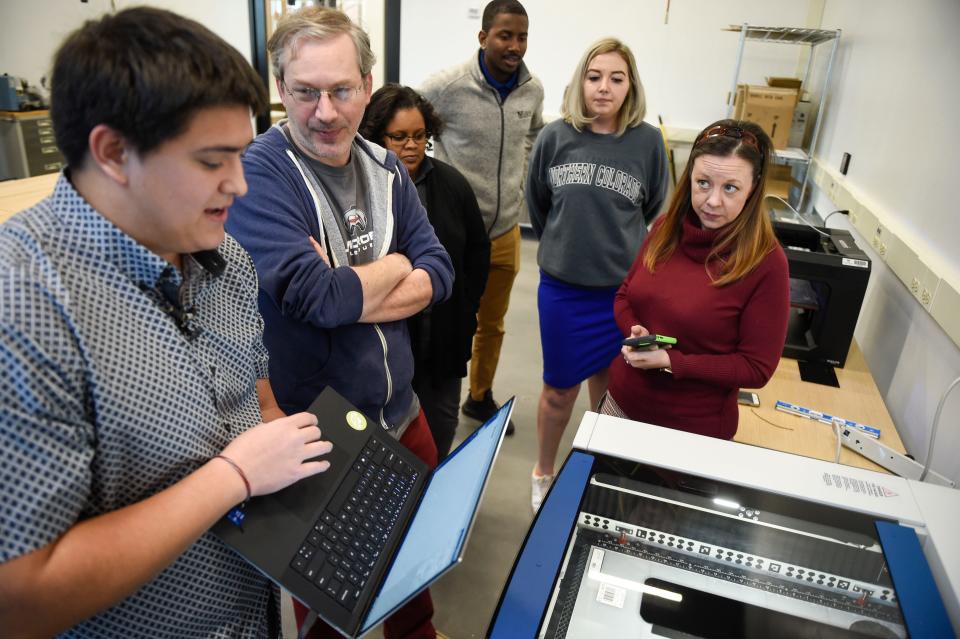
[561,38,647,135]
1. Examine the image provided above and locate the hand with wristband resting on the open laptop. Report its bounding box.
[220,413,333,496]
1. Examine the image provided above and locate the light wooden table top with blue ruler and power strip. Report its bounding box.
[733,341,905,473]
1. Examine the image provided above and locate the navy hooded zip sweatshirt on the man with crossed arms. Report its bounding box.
[227,125,453,430]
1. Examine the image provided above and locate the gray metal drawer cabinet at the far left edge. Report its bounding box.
[0,111,65,180]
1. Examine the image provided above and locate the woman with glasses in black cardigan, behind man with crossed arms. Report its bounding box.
[360,84,490,461]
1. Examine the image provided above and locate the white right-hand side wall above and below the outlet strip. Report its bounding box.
[817,0,960,480]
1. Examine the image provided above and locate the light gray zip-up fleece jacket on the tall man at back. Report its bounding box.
[420,53,543,238]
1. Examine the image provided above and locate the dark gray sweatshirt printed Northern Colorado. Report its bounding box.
[526,120,668,287]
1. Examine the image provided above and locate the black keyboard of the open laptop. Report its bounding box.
[290,437,418,612]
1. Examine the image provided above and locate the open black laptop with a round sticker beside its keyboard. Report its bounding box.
[212,387,514,637]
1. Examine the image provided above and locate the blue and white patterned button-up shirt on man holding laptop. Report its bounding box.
[0,175,278,638]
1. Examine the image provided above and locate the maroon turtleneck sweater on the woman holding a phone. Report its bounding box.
[609,214,790,439]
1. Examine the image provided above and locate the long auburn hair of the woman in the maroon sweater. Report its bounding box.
[643,120,778,287]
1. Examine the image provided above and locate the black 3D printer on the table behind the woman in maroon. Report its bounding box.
[773,220,871,377]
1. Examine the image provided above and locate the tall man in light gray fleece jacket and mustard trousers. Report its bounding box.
[420,0,543,435]
